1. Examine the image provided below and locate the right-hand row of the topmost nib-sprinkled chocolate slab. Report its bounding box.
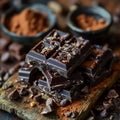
[47,38,92,78]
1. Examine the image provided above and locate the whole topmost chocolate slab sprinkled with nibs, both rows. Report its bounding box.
[26,30,91,78]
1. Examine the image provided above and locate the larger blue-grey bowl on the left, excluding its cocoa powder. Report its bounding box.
[1,4,56,46]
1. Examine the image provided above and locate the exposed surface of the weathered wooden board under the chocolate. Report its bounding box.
[0,65,120,120]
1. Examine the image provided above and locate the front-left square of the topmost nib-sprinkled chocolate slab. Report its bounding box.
[26,42,59,65]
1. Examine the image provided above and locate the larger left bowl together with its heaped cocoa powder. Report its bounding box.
[1,4,56,46]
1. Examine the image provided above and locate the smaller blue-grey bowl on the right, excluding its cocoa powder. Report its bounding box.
[67,6,112,43]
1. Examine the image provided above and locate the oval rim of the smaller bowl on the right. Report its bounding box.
[67,5,113,34]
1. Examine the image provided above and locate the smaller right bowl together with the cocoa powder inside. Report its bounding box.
[67,6,112,40]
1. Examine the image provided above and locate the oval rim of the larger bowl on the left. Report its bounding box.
[0,3,56,39]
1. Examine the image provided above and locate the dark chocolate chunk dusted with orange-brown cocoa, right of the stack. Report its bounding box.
[79,45,113,84]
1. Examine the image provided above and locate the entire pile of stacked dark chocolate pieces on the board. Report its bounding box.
[19,30,113,101]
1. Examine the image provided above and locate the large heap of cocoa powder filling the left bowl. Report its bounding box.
[5,8,49,36]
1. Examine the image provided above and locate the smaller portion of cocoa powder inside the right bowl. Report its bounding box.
[76,14,106,31]
